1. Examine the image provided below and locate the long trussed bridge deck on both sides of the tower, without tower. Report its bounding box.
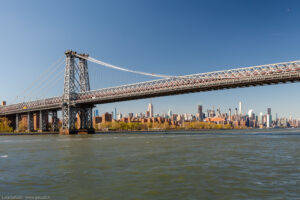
[0,61,300,117]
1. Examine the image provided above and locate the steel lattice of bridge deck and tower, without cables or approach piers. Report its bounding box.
[0,52,300,123]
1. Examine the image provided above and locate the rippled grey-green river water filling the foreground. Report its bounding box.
[0,129,300,200]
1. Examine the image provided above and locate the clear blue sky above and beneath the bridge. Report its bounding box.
[0,0,300,117]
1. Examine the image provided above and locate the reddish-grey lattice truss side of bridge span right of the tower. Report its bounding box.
[77,61,300,102]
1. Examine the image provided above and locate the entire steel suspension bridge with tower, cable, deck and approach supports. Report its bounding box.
[0,51,300,134]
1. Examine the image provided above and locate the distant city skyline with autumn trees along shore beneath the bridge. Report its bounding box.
[91,102,300,131]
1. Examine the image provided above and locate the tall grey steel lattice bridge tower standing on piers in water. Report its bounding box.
[60,51,95,135]
